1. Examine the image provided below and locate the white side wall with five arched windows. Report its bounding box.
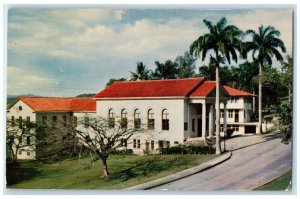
[97,99,187,153]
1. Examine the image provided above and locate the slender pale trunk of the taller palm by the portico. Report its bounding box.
[216,64,221,154]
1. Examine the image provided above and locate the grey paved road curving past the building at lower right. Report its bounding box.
[151,134,292,191]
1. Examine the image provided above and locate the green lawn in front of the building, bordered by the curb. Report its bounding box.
[6,155,217,190]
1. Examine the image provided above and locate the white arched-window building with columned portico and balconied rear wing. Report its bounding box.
[95,78,256,153]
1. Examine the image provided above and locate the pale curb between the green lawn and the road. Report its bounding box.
[124,151,232,190]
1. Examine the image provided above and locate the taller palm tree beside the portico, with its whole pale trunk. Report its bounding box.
[190,17,243,154]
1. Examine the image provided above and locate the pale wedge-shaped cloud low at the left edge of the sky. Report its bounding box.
[7,66,58,95]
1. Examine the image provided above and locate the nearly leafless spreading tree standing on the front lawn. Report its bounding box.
[49,114,143,178]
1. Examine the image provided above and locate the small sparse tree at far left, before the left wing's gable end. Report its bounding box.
[6,119,36,161]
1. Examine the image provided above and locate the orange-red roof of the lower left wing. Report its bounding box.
[19,97,96,111]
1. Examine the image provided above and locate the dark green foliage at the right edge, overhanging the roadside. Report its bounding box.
[277,103,293,144]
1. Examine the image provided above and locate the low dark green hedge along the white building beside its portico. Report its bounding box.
[159,145,214,155]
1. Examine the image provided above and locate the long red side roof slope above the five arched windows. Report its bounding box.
[95,77,204,98]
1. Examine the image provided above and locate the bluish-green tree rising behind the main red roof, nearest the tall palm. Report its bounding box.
[175,51,196,78]
